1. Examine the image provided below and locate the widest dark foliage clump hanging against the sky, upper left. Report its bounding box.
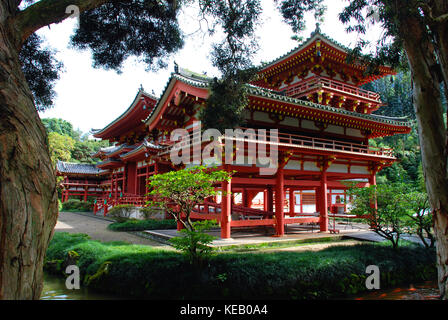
[71,0,183,70]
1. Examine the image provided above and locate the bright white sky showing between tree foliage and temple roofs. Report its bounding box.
[38,0,379,133]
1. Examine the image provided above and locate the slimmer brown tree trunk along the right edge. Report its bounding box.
[401,17,448,299]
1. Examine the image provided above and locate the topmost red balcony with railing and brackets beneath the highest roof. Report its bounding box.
[285,77,382,113]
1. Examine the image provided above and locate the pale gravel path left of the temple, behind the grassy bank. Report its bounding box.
[55,212,170,248]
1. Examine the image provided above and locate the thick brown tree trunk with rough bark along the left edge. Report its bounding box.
[0,21,58,299]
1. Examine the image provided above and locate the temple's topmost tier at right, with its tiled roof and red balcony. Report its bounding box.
[252,26,395,114]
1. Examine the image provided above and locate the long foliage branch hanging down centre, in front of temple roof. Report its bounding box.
[199,0,262,132]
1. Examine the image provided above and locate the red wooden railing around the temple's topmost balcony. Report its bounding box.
[286,77,381,102]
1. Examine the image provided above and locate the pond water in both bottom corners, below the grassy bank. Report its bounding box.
[41,273,439,300]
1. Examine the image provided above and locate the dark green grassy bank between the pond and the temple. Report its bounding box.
[45,232,436,299]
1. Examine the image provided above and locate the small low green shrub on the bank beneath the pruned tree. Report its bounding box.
[170,220,216,267]
